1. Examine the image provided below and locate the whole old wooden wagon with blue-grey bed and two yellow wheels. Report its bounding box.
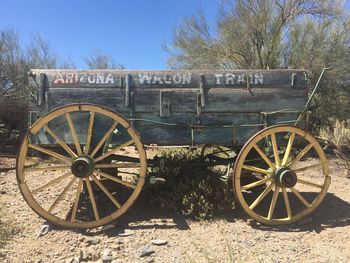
[17,70,330,228]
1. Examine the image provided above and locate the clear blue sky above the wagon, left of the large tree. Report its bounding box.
[0,0,219,69]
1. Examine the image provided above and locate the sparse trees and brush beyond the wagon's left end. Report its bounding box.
[0,29,58,147]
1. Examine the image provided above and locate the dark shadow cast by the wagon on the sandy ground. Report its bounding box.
[67,193,350,236]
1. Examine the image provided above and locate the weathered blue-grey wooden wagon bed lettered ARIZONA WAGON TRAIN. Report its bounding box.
[30,70,308,145]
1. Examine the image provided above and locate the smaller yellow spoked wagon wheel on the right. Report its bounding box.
[233,125,331,225]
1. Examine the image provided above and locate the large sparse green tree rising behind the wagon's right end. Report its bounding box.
[166,0,350,131]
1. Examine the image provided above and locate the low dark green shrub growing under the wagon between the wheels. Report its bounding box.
[142,149,234,219]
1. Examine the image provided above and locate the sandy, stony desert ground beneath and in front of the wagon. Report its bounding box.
[0,158,350,263]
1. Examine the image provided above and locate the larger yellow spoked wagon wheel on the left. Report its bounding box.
[17,104,147,228]
